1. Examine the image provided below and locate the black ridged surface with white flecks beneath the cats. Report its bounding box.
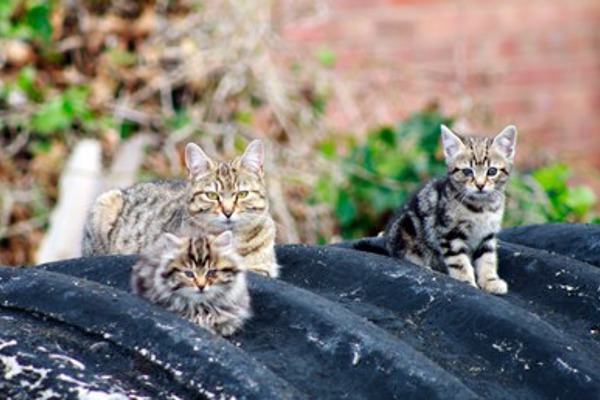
[0,224,600,399]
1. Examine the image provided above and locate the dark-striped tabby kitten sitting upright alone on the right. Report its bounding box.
[385,125,517,294]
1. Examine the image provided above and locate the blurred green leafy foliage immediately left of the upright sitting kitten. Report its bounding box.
[315,110,452,238]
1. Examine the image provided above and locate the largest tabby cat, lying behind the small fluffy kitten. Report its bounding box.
[82,140,279,277]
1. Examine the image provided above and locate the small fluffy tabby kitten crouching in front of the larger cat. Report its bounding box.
[131,231,251,336]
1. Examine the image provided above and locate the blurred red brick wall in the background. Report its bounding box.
[278,0,600,188]
